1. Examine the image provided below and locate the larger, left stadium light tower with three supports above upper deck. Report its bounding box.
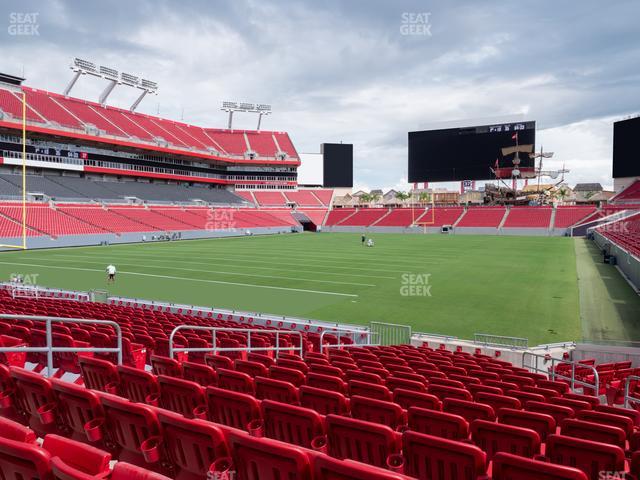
[64,57,158,112]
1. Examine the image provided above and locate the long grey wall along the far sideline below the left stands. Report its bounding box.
[0,227,302,250]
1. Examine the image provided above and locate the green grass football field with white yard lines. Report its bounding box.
[0,233,640,345]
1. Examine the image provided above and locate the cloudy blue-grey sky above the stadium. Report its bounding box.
[0,0,640,188]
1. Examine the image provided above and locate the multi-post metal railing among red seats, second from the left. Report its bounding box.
[169,325,304,358]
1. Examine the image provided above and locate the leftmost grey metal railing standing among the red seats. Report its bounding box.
[0,314,122,377]
